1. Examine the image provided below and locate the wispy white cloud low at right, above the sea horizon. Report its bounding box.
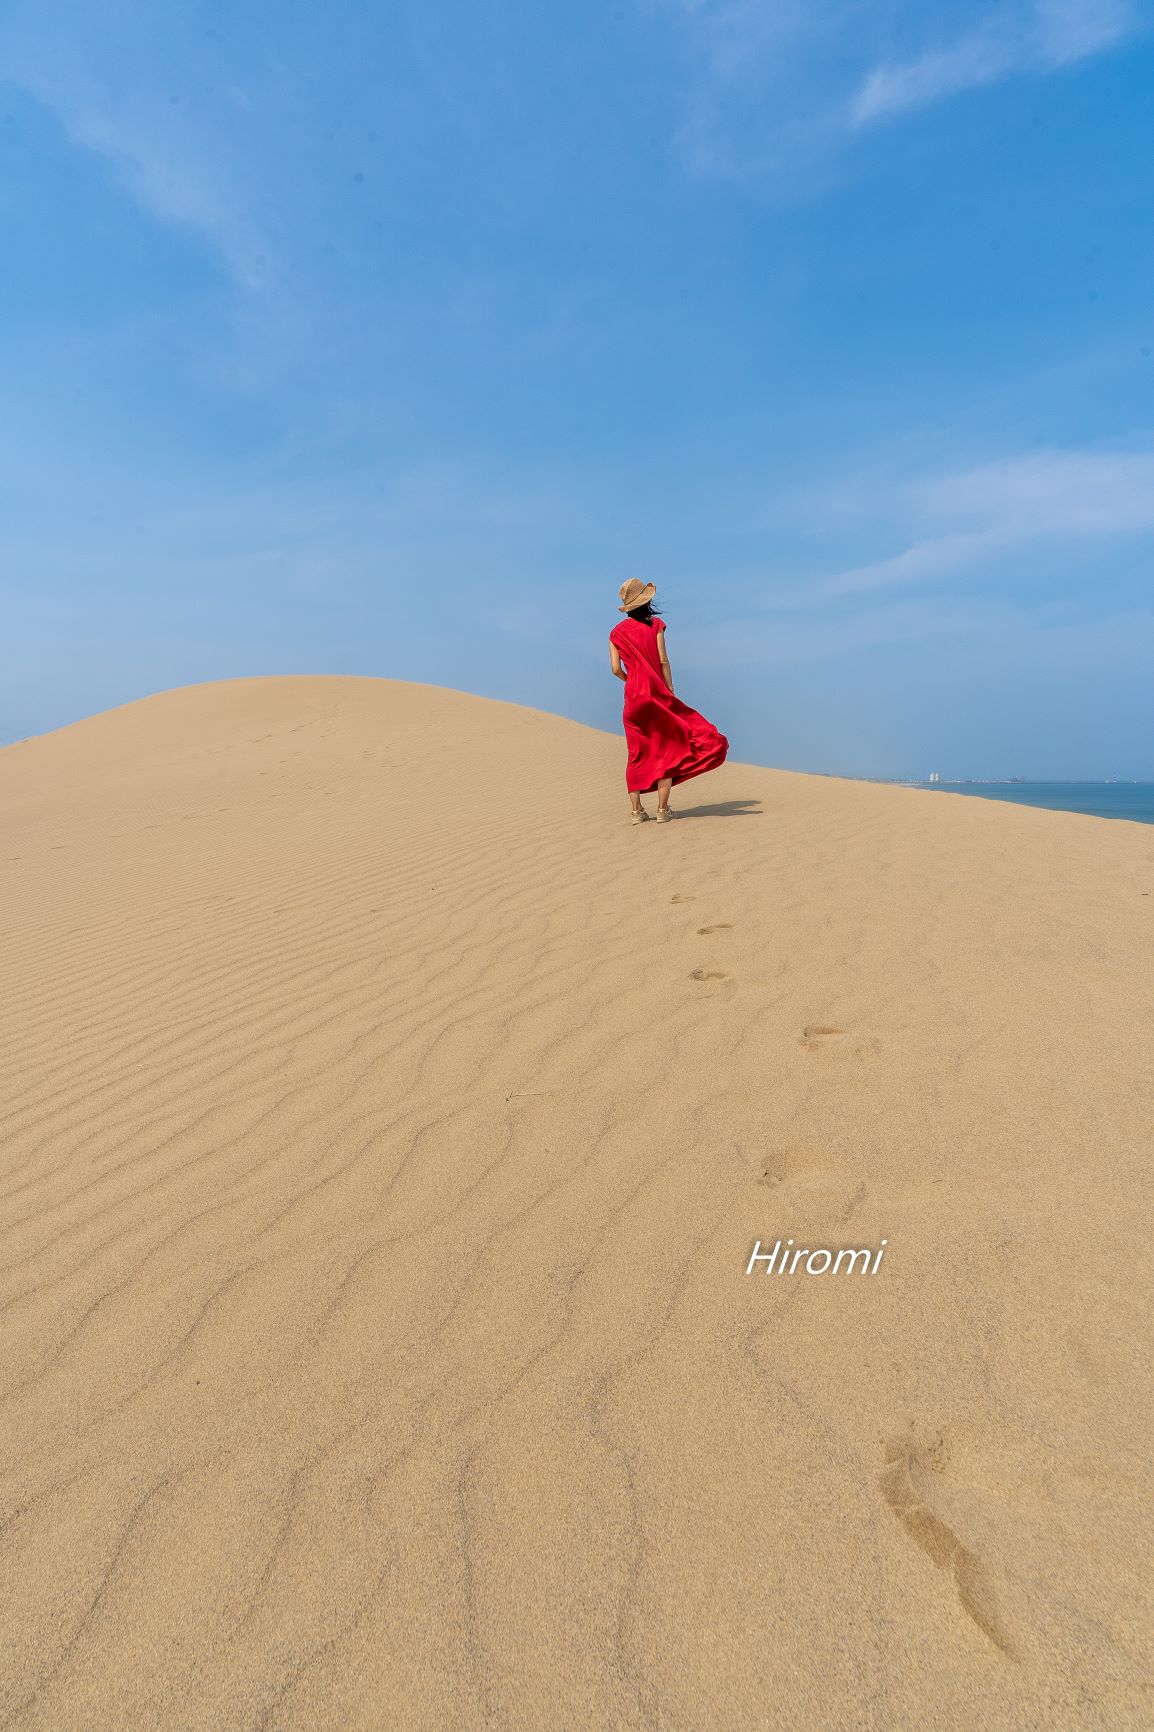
[820,450,1154,598]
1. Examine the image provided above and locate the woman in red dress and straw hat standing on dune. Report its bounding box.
[610,577,729,824]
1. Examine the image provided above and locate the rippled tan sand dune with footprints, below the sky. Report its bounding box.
[0,679,1154,1732]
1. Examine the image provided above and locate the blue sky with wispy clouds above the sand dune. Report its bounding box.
[0,0,1154,778]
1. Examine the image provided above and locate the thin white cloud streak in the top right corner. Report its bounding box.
[851,0,1135,125]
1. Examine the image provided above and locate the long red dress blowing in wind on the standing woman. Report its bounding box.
[610,615,729,793]
